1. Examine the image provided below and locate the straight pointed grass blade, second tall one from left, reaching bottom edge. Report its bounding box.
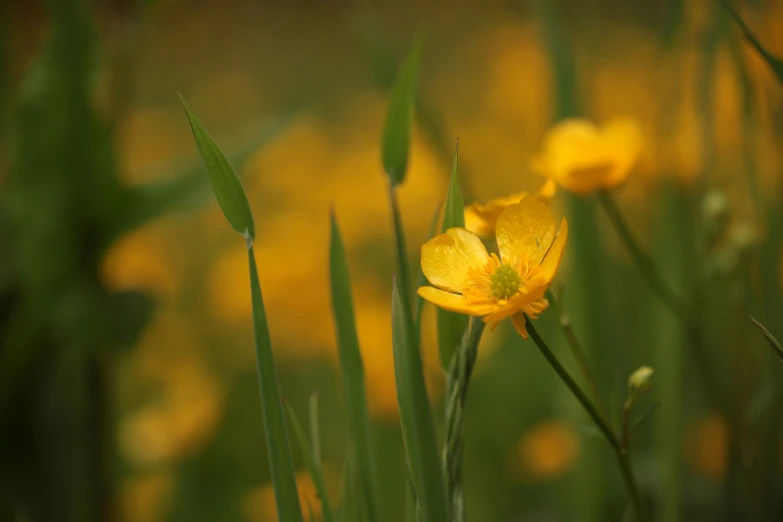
[329,212,379,522]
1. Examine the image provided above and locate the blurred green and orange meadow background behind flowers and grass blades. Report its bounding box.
[0,0,783,522]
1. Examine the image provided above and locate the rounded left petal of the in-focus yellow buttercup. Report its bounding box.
[421,228,489,292]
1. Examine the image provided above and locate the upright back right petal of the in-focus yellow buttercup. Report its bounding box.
[496,197,555,265]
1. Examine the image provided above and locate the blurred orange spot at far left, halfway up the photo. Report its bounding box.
[100,222,179,298]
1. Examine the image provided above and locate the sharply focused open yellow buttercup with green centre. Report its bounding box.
[419,197,568,339]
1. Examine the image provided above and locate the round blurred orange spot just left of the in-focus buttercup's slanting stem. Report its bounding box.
[511,420,580,480]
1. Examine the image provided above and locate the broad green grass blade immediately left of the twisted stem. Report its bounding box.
[392,278,448,522]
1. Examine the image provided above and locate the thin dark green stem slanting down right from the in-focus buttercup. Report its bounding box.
[525,317,647,522]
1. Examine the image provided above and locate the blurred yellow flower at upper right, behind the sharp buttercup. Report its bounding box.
[532,118,642,194]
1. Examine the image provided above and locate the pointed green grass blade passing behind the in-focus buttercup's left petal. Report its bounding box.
[438,141,469,370]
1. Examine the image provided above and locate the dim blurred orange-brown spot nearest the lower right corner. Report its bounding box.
[685,415,729,479]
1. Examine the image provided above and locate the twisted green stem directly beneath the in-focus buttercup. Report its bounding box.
[443,317,484,522]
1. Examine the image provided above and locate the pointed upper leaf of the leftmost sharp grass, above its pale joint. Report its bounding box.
[178,94,256,242]
